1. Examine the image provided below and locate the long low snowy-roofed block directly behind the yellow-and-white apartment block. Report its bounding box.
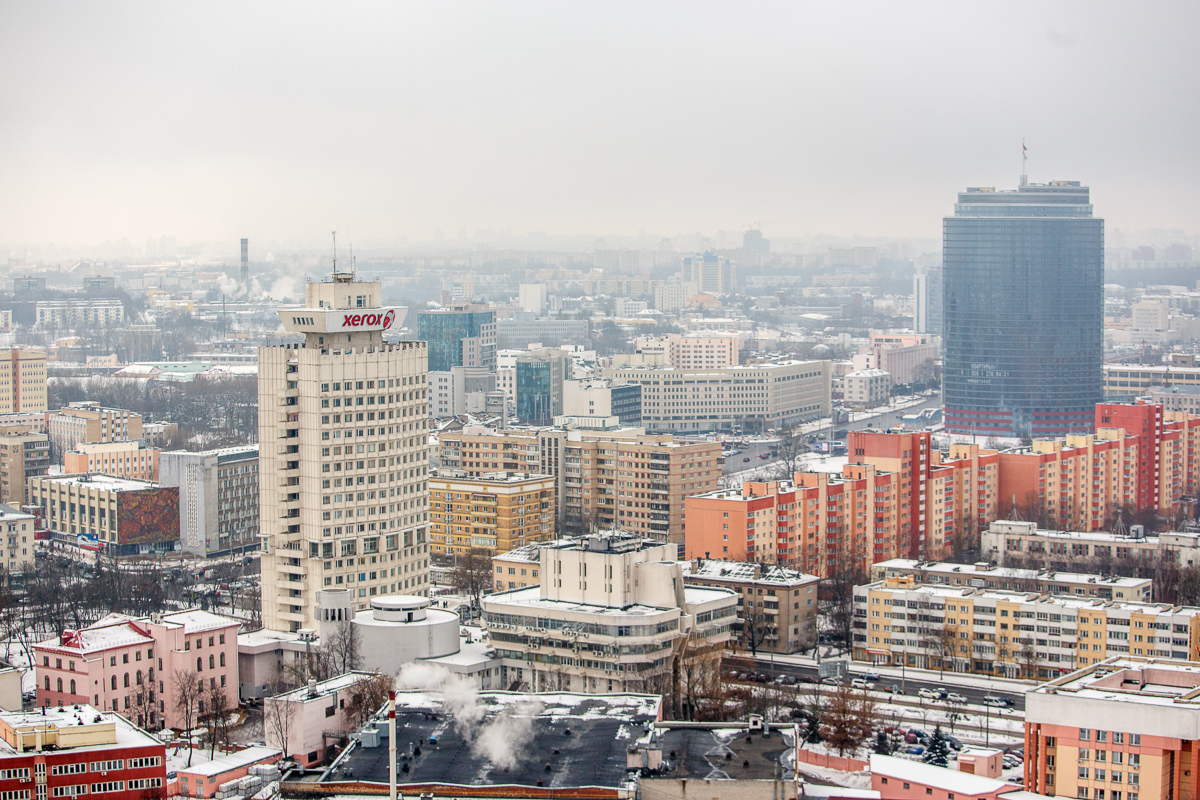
[871,559,1153,602]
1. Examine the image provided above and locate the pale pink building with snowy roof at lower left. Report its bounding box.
[34,609,239,730]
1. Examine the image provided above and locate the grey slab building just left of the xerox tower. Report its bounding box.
[160,445,259,558]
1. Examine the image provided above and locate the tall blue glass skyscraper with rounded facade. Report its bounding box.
[942,178,1104,438]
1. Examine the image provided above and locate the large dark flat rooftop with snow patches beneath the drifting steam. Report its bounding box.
[320,692,661,788]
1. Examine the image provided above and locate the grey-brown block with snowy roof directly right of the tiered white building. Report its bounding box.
[683,559,821,652]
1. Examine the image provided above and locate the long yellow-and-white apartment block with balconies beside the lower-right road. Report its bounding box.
[852,576,1200,680]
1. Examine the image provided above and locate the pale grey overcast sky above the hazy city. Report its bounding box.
[0,0,1200,243]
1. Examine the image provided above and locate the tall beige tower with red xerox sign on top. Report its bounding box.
[258,271,430,631]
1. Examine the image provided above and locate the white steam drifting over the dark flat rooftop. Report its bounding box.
[396,662,542,770]
